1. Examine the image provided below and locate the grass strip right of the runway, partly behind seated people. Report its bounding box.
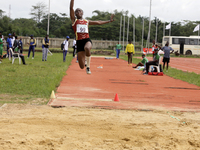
[120,55,200,87]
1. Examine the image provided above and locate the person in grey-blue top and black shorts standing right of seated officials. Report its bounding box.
[161,41,174,72]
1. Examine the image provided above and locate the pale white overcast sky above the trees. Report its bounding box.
[0,0,200,22]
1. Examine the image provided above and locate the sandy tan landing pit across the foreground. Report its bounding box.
[0,104,200,150]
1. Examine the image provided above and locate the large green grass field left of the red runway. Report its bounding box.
[0,52,72,103]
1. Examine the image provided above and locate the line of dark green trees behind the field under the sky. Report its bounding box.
[0,3,200,43]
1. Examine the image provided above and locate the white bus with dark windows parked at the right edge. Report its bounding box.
[162,36,200,55]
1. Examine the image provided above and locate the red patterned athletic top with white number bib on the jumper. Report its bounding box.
[72,19,89,40]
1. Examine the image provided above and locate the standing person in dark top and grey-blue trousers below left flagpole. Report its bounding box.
[42,35,50,61]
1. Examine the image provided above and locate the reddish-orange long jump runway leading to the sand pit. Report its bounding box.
[49,57,200,111]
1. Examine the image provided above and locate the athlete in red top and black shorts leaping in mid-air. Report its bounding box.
[70,0,114,74]
